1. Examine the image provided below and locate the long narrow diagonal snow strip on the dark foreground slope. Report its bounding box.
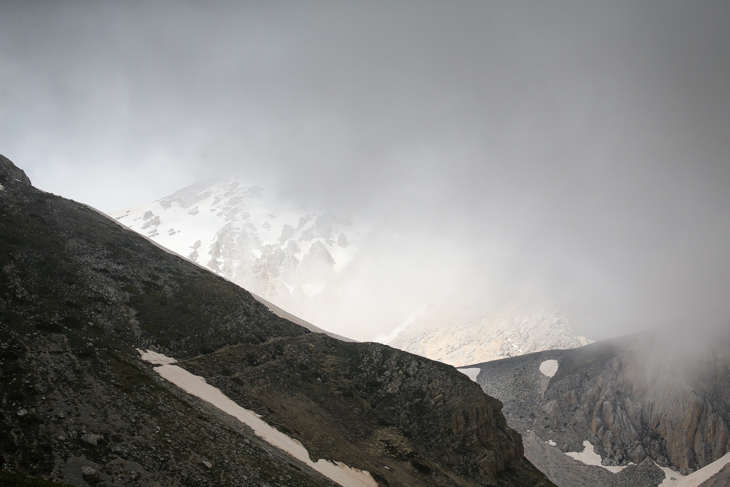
[139,350,378,487]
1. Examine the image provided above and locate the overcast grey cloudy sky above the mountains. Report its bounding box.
[0,0,730,338]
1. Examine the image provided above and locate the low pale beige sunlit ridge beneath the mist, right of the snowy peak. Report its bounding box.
[375,303,590,367]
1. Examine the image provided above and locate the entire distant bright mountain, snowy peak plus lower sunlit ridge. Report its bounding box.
[111,178,588,356]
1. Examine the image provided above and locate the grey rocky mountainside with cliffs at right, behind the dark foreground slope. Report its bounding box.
[460,330,730,486]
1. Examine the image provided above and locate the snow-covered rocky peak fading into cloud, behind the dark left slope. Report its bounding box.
[110,178,372,338]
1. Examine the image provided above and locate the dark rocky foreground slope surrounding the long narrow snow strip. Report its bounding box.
[0,158,552,487]
